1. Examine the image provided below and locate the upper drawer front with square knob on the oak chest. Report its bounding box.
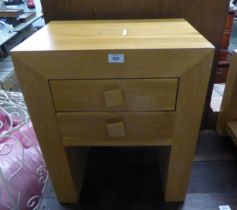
[50,79,178,111]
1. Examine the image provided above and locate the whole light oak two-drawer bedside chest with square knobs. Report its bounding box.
[12,19,214,203]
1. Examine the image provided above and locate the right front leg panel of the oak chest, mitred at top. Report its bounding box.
[164,52,213,201]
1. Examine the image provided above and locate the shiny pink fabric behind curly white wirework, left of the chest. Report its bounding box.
[0,111,48,210]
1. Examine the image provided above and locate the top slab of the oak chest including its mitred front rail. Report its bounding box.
[14,19,213,79]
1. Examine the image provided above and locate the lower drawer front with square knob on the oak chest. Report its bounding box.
[56,112,175,146]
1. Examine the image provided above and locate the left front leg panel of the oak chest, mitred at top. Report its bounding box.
[10,56,83,203]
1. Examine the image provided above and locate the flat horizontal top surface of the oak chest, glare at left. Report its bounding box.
[13,19,213,52]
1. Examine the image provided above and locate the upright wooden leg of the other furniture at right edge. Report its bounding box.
[217,51,237,135]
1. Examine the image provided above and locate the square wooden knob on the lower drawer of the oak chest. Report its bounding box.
[106,121,126,138]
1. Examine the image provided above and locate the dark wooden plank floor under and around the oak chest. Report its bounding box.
[40,130,237,210]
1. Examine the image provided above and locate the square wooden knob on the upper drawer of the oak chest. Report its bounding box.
[103,90,124,108]
